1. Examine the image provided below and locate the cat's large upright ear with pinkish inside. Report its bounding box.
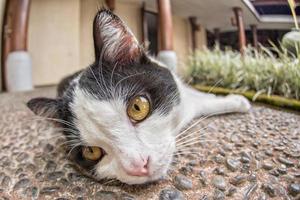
[93,10,143,64]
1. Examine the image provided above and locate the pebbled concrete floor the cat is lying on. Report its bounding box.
[0,88,300,200]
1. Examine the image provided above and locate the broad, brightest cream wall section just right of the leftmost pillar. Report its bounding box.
[28,0,80,85]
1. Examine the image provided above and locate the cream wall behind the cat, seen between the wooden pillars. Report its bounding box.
[27,0,202,86]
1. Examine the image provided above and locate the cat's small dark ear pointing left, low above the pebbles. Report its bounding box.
[27,97,60,118]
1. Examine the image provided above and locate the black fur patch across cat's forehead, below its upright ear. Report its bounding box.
[79,59,179,114]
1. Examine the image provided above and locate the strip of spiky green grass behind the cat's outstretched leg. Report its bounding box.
[187,46,300,100]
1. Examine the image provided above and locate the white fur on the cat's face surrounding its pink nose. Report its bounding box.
[71,88,179,184]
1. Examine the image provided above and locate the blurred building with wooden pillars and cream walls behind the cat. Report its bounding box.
[0,0,300,94]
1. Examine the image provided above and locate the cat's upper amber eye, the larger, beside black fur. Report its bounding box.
[127,96,150,122]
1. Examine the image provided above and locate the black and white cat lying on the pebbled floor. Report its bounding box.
[27,9,251,184]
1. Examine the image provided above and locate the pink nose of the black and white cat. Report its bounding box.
[124,157,149,176]
